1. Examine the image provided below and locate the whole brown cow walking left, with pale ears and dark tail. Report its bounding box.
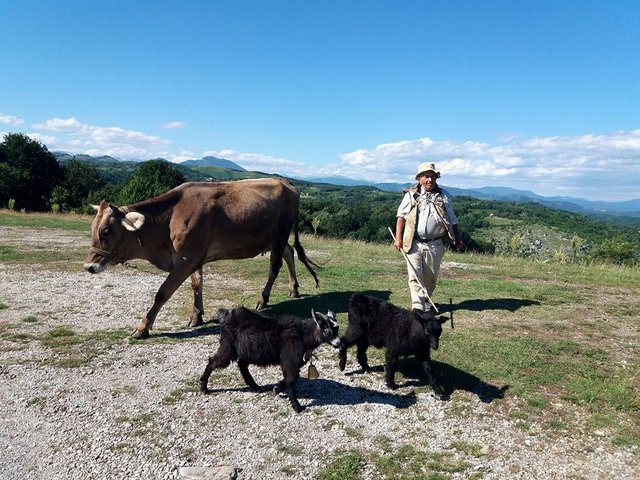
[84,178,318,338]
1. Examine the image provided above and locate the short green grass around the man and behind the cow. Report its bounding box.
[0,211,640,472]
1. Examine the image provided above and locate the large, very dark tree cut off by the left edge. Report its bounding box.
[0,133,64,211]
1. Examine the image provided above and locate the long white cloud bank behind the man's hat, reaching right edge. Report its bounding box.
[333,129,640,200]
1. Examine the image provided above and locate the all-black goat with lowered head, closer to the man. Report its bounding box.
[339,293,447,398]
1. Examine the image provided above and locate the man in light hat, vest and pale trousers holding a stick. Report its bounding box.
[394,163,462,310]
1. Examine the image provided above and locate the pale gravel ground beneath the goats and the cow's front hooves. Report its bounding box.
[0,227,640,480]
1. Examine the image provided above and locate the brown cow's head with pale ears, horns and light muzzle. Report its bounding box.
[84,200,145,273]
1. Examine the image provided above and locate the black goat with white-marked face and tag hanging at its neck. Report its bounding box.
[200,307,340,412]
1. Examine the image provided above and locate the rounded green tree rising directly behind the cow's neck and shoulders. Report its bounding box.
[116,160,185,205]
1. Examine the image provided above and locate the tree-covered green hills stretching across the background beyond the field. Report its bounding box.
[0,134,640,265]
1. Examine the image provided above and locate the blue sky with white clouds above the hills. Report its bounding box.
[0,0,640,201]
